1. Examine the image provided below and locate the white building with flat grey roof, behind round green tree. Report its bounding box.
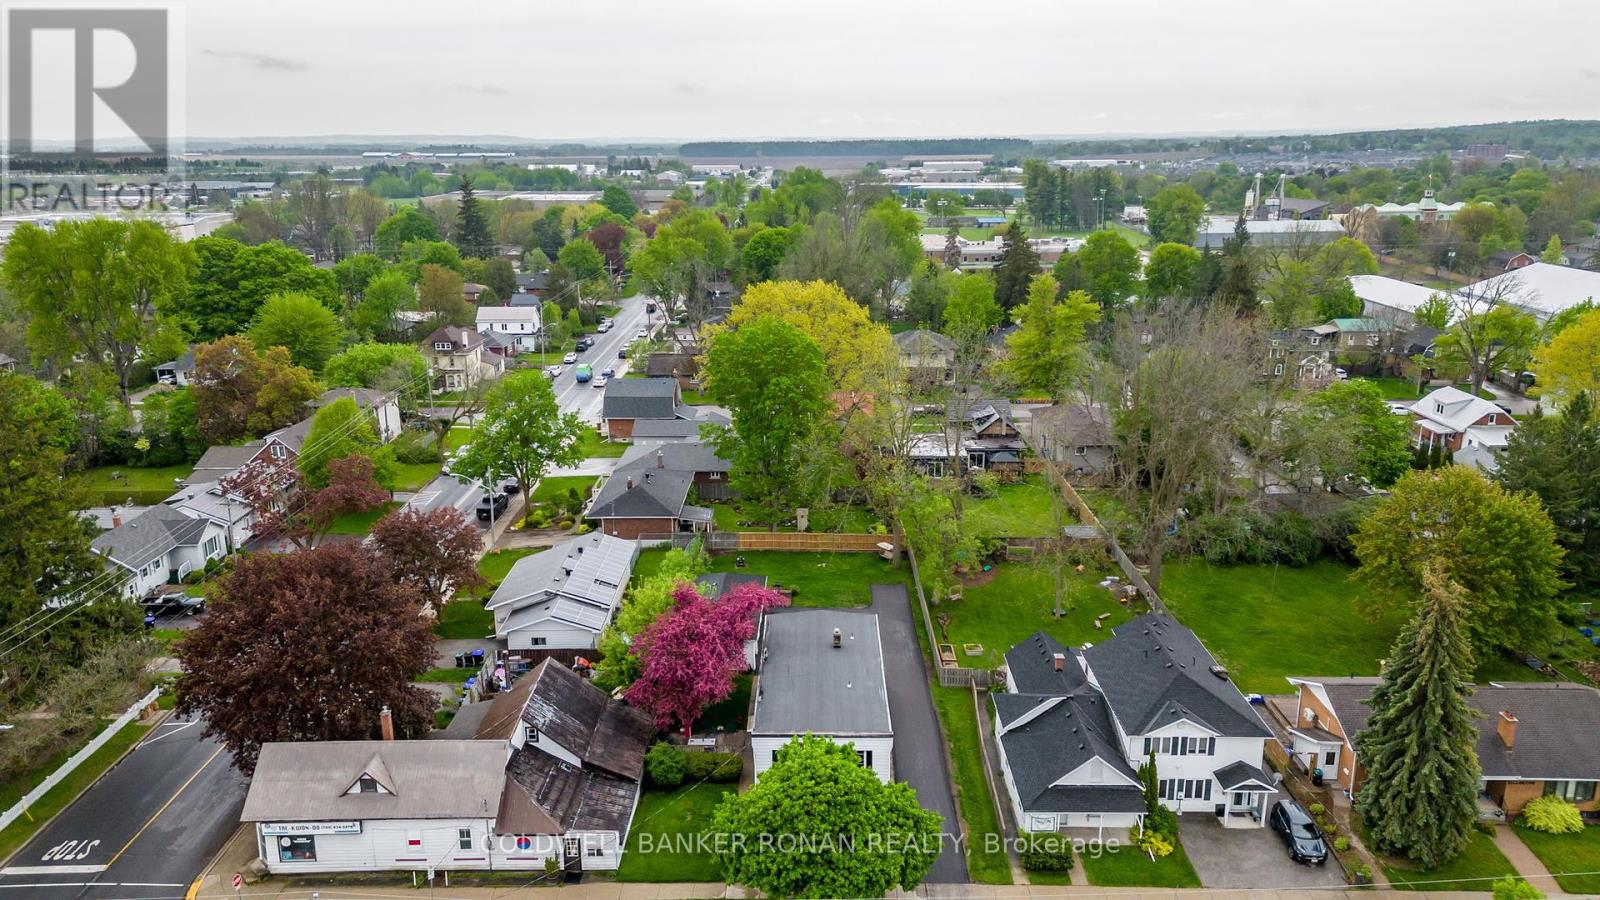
[750,607,894,781]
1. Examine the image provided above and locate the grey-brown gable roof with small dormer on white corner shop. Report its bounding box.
[238,740,506,822]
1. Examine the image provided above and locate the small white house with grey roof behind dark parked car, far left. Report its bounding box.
[90,504,227,599]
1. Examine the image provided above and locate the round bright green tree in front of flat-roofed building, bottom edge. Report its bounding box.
[710,735,942,897]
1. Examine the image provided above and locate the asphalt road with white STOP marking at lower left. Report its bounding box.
[0,719,245,900]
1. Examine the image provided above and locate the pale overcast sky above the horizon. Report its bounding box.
[187,0,1600,139]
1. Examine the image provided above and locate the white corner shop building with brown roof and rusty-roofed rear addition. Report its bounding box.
[240,660,654,874]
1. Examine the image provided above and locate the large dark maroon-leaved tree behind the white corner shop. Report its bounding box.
[178,543,438,775]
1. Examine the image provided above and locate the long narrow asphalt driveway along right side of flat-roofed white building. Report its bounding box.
[872,585,966,884]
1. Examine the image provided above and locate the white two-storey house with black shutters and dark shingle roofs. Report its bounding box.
[994,615,1275,831]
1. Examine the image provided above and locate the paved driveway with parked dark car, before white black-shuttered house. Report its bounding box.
[1179,802,1344,889]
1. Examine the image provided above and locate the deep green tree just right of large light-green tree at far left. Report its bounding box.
[176,235,339,341]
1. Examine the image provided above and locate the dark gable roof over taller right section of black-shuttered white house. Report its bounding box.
[1083,613,1272,737]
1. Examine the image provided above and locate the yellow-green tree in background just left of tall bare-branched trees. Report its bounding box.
[1005,275,1104,399]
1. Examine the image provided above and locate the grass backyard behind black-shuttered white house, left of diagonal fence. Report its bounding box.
[928,562,1144,668]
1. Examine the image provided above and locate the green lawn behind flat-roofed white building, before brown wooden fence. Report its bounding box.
[634,549,910,607]
